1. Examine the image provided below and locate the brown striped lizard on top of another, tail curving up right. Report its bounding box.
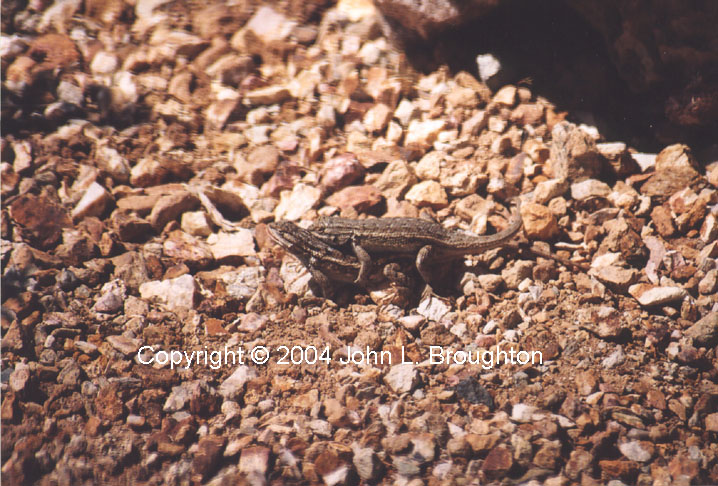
[309,198,522,285]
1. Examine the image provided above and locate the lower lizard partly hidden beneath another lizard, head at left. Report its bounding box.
[267,220,408,297]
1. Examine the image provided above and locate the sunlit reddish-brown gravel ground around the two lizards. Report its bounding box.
[0,0,718,486]
